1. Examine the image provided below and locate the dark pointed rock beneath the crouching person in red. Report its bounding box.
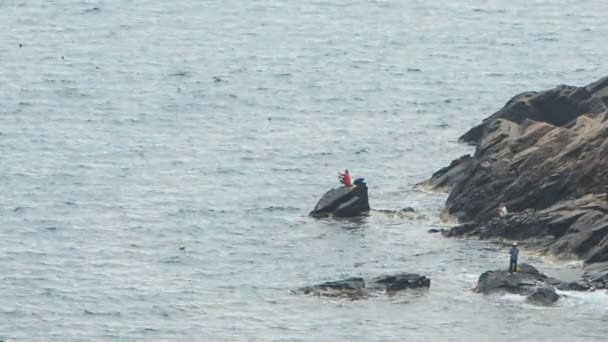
[309,181,370,218]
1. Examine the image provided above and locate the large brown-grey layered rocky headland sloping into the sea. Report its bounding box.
[428,77,608,263]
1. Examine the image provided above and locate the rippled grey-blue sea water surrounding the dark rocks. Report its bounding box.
[0,0,608,342]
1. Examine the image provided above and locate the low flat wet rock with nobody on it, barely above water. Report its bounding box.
[299,273,431,300]
